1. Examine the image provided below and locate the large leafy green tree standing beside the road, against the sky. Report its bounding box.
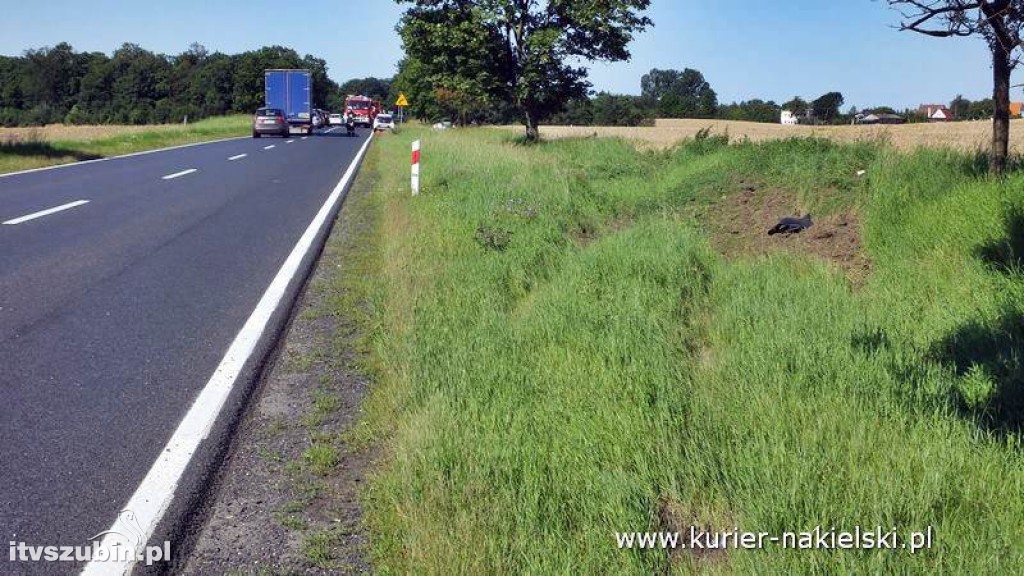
[395,0,651,140]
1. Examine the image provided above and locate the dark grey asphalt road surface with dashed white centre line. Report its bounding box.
[0,126,368,574]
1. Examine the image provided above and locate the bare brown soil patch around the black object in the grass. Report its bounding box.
[709,180,870,283]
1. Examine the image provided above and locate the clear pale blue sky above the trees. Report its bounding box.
[0,0,1007,108]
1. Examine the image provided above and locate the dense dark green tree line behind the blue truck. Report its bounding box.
[0,43,390,126]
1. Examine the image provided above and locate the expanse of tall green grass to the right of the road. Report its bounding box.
[352,128,1024,574]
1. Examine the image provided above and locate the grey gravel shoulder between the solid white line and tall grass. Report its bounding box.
[180,151,378,575]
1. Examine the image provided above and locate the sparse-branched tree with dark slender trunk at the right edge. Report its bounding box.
[888,0,1024,172]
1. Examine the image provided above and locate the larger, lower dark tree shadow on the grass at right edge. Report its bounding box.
[932,311,1024,434]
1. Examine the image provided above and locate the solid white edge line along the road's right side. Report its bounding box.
[82,131,373,576]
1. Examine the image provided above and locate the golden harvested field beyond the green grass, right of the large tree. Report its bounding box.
[524,119,1024,154]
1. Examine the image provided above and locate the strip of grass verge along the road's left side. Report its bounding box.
[0,115,251,173]
